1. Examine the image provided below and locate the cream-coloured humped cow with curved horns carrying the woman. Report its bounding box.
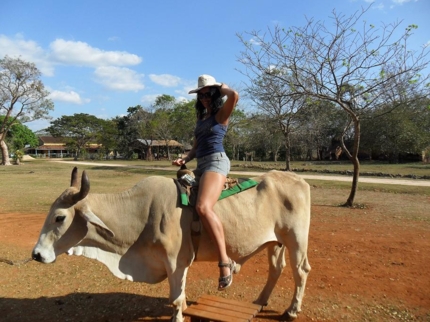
[32,168,311,321]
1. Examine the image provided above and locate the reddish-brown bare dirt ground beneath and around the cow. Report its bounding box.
[0,191,430,322]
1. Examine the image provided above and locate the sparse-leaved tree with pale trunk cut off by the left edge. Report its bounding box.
[0,56,54,165]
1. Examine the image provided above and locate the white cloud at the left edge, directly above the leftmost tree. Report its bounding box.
[0,34,54,76]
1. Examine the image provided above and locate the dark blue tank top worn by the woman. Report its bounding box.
[194,115,228,158]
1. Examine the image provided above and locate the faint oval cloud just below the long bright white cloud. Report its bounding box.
[94,66,145,92]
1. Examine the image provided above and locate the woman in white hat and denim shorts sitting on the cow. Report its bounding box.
[172,75,239,291]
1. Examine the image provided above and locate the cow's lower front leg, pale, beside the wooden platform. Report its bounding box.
[168,266,188,322]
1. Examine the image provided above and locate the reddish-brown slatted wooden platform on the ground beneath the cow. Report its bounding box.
[183,295,262,322]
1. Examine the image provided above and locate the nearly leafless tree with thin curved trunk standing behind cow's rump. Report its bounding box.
[239,6,430,206]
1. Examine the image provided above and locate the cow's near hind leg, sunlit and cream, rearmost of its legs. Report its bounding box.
[284,233,311,320]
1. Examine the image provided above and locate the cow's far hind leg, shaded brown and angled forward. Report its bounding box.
[254,243,287,305]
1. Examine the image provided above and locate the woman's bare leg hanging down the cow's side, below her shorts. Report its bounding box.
[196,171,231,286]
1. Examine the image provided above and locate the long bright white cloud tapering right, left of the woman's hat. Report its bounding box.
[50,39,142,67]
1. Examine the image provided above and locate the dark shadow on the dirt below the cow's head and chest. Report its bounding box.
[0,293,173,322]
